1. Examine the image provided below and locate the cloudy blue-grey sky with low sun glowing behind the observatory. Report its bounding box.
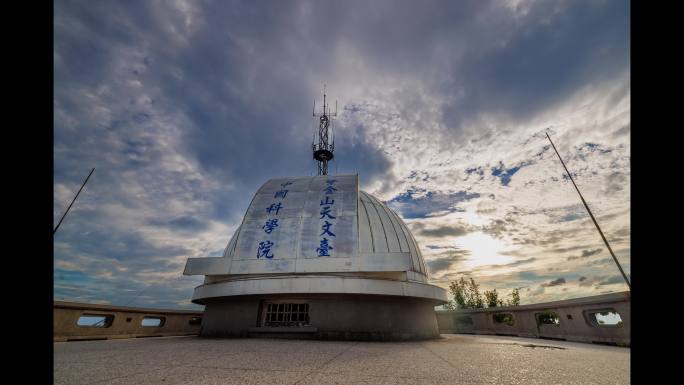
[53,0,631,308]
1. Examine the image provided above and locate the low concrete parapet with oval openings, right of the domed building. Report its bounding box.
[436,292,630,345]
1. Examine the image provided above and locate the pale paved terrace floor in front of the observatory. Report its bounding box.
[54,334,630,385]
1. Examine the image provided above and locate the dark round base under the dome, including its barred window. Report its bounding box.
[200,294,441,341]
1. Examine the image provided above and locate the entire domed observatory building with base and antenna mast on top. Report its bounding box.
[184,90,447,340]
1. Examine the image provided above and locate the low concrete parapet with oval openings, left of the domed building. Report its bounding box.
[53,301,203,341]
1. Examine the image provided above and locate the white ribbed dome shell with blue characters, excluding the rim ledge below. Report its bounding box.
[185,174,427,282]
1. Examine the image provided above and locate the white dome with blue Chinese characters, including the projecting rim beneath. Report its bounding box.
[184,175,447,303]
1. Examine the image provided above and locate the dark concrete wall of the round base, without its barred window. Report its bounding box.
[200,294,439,341]
